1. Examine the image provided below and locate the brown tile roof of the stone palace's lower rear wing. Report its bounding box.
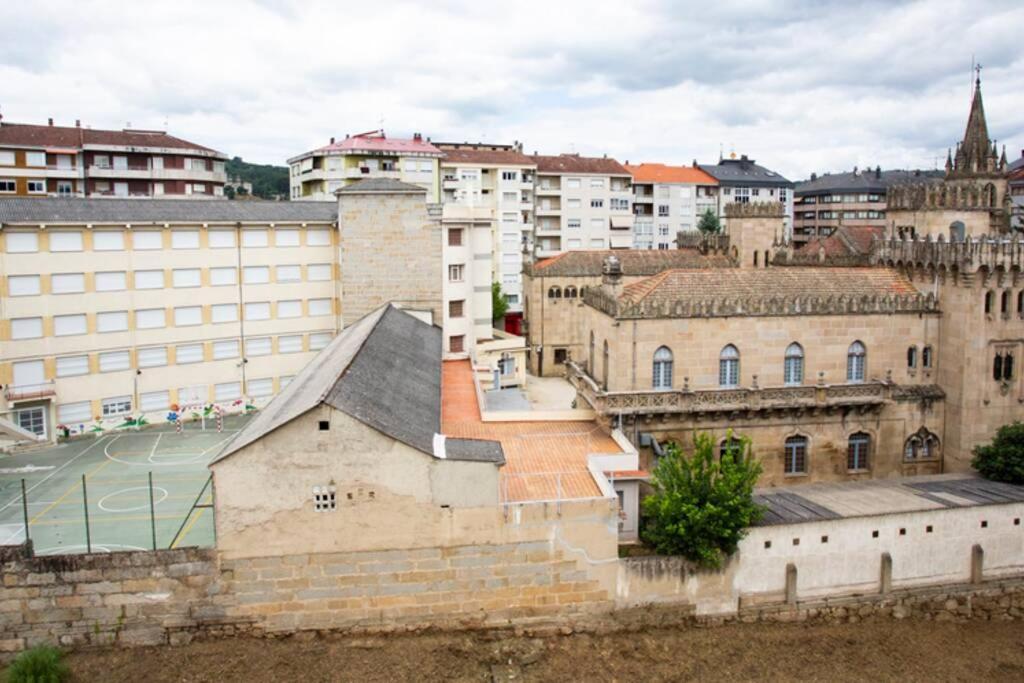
[527,249,735,278]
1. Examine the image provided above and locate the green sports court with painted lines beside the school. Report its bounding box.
[0,416,247,555]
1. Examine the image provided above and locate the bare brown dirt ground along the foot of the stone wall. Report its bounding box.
[44,622,1024,683]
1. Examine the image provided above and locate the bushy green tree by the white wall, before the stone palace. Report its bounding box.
[641,431,762,568]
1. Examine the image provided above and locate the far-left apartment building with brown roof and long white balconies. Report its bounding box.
[0,119,227,199]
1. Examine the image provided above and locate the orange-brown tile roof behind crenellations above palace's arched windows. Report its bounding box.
[618,267,921,303]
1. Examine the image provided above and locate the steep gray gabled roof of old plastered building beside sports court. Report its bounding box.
[214,304,505,464]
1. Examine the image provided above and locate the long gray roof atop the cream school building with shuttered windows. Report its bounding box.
[0,197,338,224]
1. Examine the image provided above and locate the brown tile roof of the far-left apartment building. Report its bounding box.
[0,123,226,158]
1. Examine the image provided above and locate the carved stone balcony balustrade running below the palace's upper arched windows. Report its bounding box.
[565,360,893,415]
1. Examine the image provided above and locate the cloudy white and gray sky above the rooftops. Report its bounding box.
[0,0,1024,179]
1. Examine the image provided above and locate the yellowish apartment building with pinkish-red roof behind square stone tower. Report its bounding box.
[288,130,443,203]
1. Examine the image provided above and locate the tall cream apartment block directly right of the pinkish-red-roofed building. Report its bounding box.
[436,142,537,319]
